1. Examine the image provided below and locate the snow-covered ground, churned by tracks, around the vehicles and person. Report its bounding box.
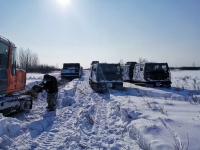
[0,70,200,150]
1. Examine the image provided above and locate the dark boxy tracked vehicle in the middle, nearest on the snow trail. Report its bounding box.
[89,61,123,92]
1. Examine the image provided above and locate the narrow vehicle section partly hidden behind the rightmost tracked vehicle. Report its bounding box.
[121,62,137,82]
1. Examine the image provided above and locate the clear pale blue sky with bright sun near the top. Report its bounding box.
[0,0,200,68]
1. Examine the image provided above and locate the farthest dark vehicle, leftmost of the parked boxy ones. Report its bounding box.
[61,63,83,79]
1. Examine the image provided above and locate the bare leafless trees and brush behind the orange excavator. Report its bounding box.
[16,48,59,73]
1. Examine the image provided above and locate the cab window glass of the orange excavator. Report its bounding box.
[0,41,9,68]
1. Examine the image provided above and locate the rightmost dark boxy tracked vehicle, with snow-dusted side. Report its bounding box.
[133,63,172,87]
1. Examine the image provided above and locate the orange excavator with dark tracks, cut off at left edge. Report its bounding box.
[0,36,32,115]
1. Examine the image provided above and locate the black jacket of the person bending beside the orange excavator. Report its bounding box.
[41,75,58,94]
